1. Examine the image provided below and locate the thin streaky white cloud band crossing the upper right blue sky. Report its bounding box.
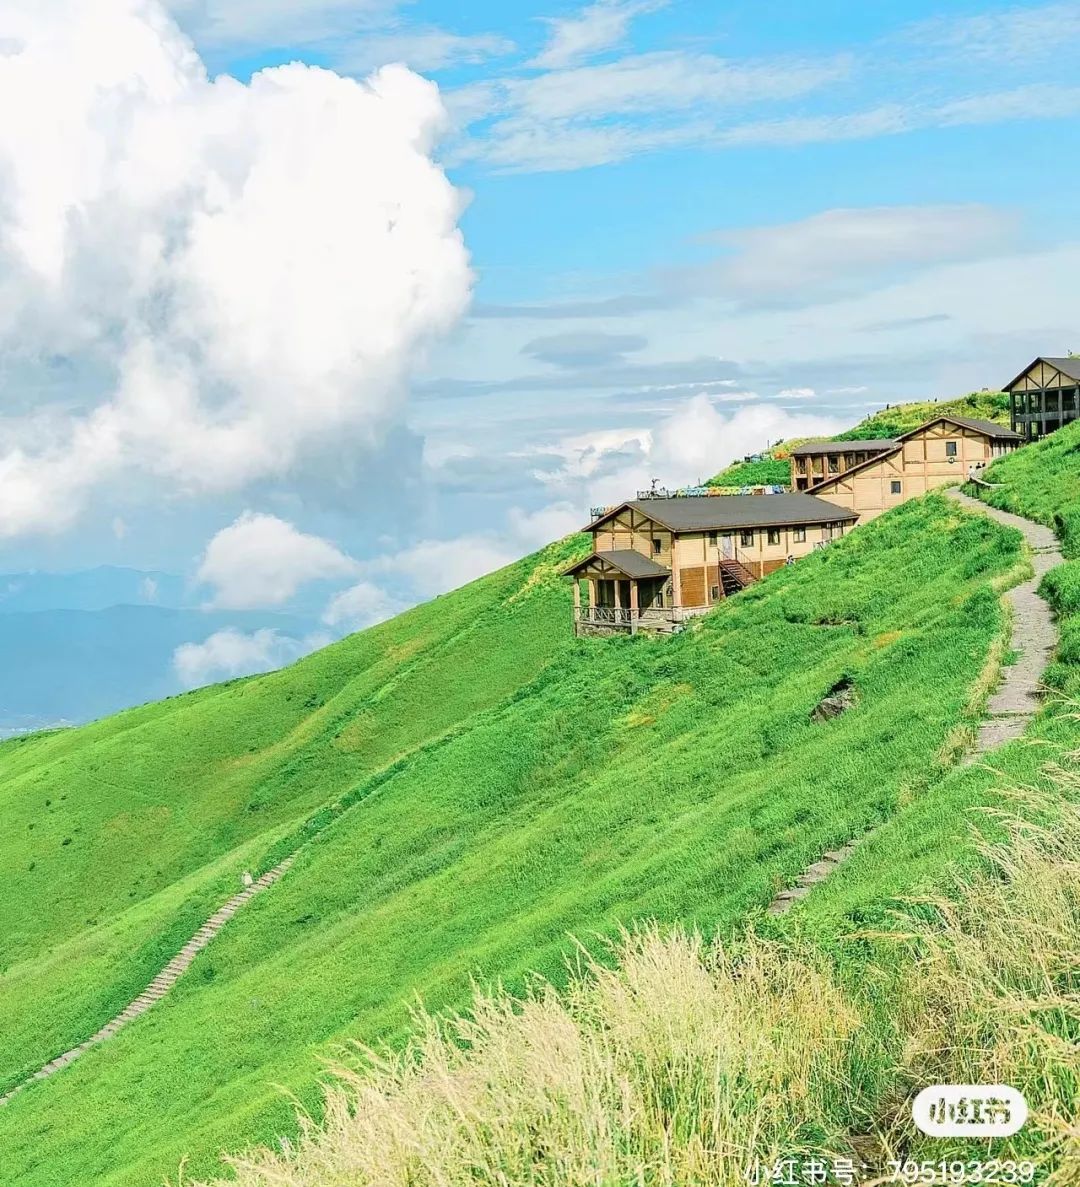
[447,0,1080,172]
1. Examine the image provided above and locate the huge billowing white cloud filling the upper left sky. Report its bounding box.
[0,0,471,537]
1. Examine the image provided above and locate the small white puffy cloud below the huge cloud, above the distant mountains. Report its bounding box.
[197,512,360,610]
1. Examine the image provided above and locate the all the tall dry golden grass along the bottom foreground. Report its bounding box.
[188,767,1080,1187]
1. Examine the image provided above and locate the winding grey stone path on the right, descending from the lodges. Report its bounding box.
[769,490,1063,915]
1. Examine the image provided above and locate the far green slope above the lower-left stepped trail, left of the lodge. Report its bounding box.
[0,541,591,1090]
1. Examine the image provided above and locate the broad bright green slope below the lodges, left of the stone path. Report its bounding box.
[0,497,1018,1187]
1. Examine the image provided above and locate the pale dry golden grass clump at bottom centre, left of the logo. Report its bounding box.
[194,928,859,1187]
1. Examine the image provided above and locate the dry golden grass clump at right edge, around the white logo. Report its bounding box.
[892,783,1080,1187]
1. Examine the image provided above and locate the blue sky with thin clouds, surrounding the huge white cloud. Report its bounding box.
[0,0,1080,688]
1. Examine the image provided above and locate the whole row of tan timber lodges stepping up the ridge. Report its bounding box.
[564,357,1080,635]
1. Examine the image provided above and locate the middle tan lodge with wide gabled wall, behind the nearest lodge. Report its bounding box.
[809,415,1023,523]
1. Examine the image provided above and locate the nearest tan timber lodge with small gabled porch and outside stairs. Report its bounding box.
[565,494,858,635]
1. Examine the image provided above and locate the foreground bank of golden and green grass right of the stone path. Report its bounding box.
[189,425,1080,1187]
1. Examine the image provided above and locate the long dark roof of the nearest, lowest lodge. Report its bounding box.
[585,494,858,532]
